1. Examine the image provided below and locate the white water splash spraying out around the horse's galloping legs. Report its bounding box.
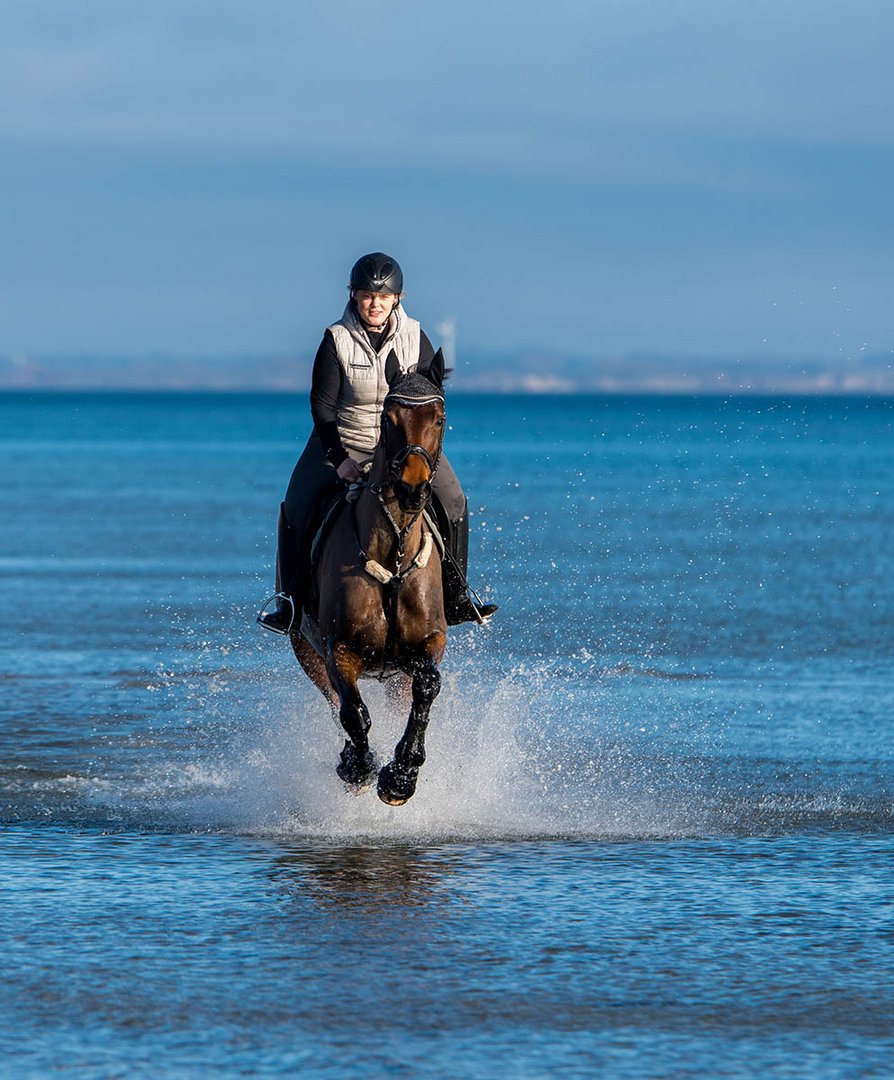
[0,622,894,843]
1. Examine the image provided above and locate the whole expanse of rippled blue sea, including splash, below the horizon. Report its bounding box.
[0,394,894,1077]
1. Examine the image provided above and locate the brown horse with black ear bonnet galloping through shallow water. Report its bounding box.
[289,350,447,806]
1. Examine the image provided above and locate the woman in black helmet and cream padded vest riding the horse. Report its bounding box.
[258,252,497,634]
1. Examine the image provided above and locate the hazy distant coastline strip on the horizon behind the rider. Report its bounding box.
[0,352,894,396]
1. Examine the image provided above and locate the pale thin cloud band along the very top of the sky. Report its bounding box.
[0,2,894,157]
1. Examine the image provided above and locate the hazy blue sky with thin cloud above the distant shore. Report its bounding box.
[0,0,894,366]
